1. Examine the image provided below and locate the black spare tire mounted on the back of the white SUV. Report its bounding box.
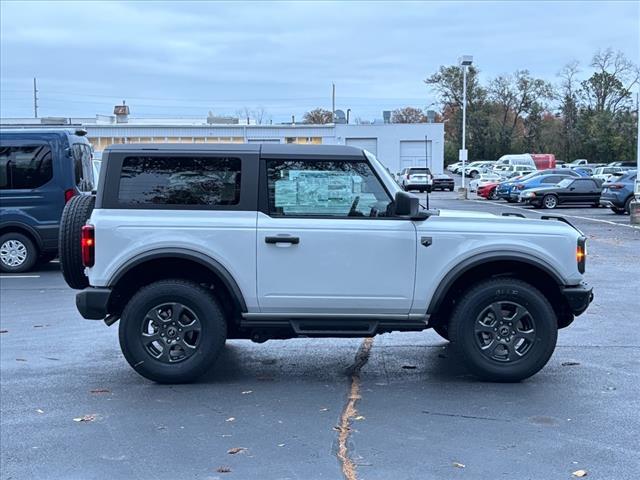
[58,195,96,290]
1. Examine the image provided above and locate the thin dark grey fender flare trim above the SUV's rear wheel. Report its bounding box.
[107,248,247,313]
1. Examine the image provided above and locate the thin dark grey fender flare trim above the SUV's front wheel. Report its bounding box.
[427,252,565,315]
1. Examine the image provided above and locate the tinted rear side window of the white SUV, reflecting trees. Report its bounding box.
[119,156,241,206]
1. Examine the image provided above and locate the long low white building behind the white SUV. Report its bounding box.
[0,115,444,173]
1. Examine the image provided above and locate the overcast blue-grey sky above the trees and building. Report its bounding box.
[0,0,640,122]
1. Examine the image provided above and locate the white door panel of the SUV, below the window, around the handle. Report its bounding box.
[257,213,416,315]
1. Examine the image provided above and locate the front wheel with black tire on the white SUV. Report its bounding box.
[449,278,558,382]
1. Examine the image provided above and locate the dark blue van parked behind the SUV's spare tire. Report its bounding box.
[0,128,95,273]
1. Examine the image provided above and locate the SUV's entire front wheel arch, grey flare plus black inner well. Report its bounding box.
[427,252,573,324]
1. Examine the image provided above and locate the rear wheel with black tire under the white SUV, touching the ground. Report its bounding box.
[119,280,227,383]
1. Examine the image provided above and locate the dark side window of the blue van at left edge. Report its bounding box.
[0,145,53,190]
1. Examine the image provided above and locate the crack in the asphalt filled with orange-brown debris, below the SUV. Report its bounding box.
[336,337,373,480]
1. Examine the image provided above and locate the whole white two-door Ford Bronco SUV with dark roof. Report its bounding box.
[60,144,593,383]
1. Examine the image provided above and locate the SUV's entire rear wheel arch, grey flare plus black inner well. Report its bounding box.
[107,248,247,317]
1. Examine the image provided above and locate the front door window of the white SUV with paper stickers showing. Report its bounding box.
[267,160,391,218]
